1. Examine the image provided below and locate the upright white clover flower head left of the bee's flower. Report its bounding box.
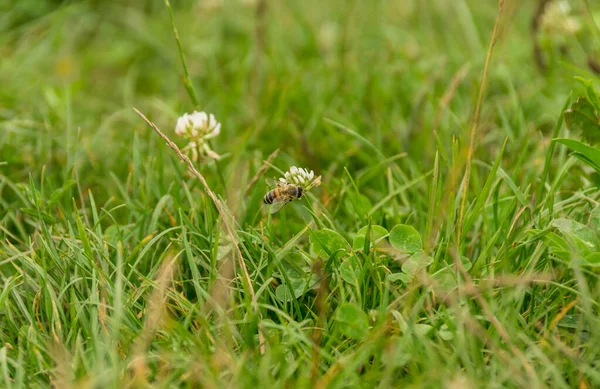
[175,111,221,162]
